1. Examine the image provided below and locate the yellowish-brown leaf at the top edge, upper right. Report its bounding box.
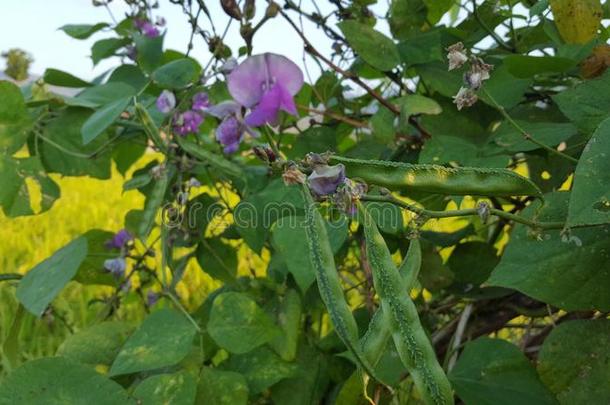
[549,0,603,44]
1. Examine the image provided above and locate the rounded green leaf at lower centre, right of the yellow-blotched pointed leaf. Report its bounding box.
[208,292,279,354]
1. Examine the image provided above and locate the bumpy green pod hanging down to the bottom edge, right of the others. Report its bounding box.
[359,205,453,405]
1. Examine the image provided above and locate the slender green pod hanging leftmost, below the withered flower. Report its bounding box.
[302,185,374,377]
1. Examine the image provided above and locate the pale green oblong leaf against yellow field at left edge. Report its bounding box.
[16,237,87,317]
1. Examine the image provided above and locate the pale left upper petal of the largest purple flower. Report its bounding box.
[227,55,268,107]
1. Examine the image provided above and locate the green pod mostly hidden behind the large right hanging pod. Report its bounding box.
[360,239,421,367]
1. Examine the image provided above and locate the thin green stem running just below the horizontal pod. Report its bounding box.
[361,195,565,229]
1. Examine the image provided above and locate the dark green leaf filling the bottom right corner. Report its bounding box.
[538,319,610,405]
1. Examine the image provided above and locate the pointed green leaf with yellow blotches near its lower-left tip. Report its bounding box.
[109,309,197,376]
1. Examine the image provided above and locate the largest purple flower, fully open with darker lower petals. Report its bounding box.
[227,53,303,126]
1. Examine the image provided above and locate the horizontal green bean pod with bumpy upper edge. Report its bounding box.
[330,155,542,197]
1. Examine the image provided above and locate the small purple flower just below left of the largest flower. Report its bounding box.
[204,101,258,153]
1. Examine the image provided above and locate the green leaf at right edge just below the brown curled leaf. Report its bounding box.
[553,63,610,134]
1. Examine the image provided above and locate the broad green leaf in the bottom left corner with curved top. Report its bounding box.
[0,357,135,405]
